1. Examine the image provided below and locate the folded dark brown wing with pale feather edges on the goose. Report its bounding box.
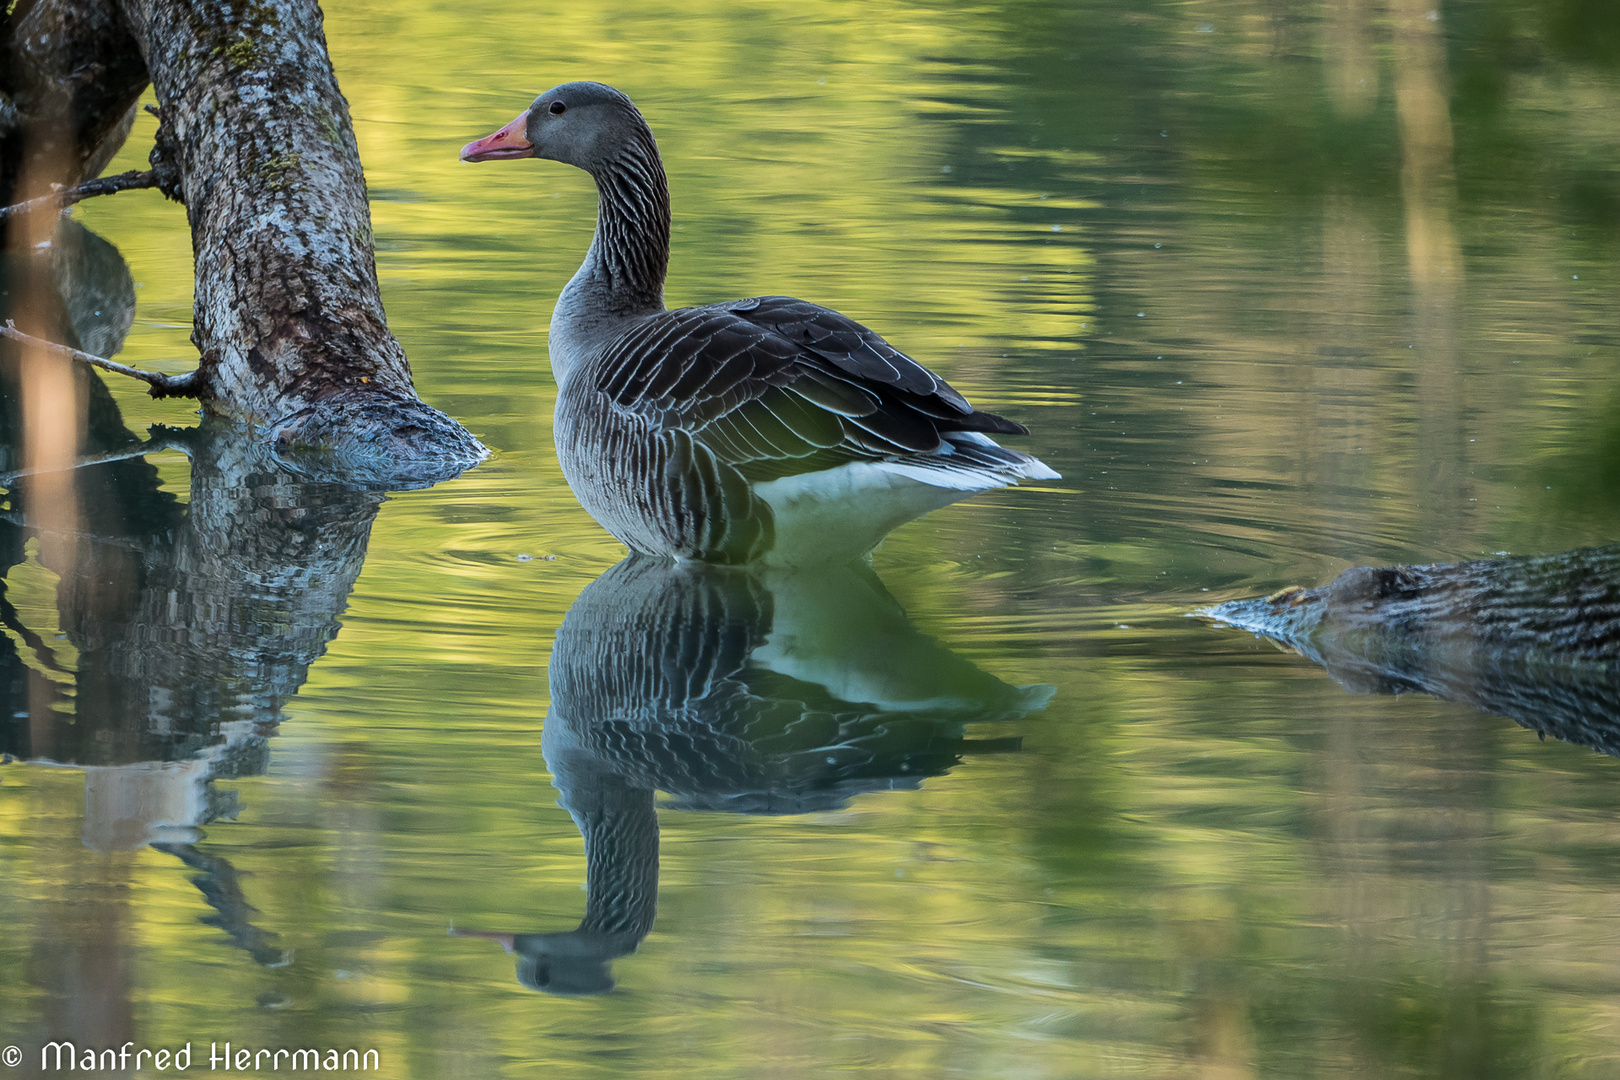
[601,296,1027,481]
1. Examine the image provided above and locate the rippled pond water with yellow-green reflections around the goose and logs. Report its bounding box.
[0,0,1620,1078]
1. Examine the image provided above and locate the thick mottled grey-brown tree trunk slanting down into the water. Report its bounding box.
[120,0,484,481]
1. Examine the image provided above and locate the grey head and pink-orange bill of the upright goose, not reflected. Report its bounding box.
[462,83,646,173]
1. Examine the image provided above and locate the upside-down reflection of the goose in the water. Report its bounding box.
[457,555,1051,994]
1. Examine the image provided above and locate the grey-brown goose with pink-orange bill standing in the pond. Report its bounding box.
[462,83,1058,565]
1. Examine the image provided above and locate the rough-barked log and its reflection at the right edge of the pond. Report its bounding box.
[1200,546,1620,756]
